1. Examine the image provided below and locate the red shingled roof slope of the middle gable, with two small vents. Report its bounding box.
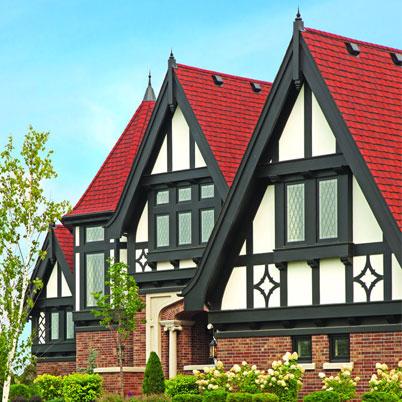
[176,64,272,186]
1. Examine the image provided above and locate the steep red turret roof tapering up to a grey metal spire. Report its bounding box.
[67,101,155,216]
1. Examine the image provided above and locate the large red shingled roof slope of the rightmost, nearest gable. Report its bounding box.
[302,28,402,230]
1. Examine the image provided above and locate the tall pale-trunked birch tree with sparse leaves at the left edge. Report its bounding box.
[0,127,69,402]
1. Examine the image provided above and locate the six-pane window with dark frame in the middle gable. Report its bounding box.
[150,183,220,249]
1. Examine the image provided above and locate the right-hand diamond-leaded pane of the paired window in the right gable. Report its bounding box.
[319,179,338,239]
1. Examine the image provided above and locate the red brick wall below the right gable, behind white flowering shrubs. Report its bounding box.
[217,332,402,396]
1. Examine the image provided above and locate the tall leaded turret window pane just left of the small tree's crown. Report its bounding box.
[85,253,105,307]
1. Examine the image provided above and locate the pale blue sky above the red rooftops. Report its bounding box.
[0,0,402,207]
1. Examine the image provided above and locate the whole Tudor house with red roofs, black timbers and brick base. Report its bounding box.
[31,15,402,392]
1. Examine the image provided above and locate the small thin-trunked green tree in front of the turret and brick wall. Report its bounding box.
[93,262,145,397]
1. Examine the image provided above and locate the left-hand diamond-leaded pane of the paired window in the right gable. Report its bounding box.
[287,183,305,242]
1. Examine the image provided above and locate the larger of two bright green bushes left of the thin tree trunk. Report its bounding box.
[63,373,102,402]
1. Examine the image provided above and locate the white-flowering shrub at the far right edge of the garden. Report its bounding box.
[369,360,402,399]
